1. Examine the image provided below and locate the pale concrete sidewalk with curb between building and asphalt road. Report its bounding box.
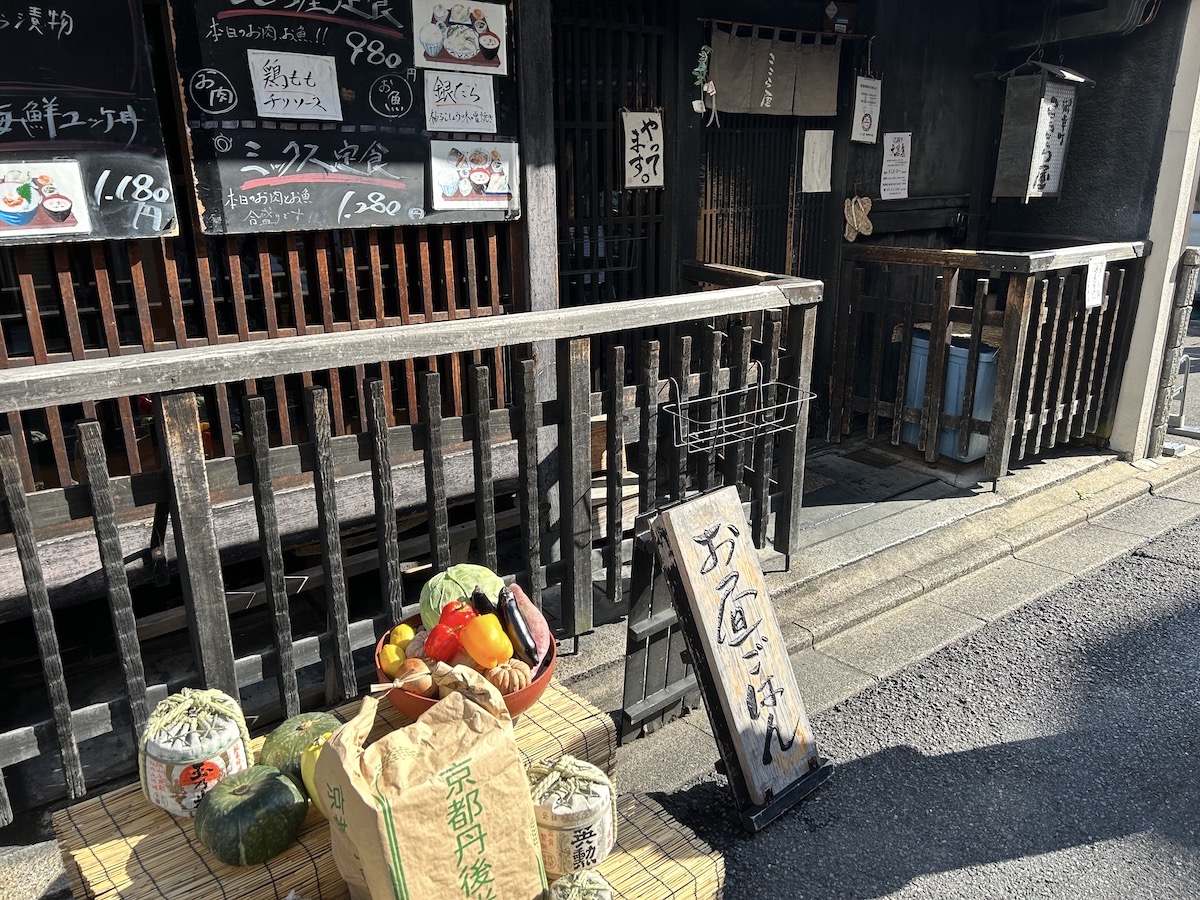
[11,444,1200,900]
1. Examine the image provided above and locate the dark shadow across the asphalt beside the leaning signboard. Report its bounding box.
[655,585,1200,898]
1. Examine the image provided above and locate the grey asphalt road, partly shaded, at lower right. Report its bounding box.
[659,523,1200,900]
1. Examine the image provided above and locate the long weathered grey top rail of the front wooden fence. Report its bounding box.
[0,281,821,412]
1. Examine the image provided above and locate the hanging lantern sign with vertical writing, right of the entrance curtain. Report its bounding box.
[991,62,1094,203]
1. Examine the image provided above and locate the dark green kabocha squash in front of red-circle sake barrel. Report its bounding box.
[196,766,308,865]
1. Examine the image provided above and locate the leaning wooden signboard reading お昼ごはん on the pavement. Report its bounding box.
[653,487,832,832]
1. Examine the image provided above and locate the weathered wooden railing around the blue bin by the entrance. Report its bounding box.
[829,242,1146,481]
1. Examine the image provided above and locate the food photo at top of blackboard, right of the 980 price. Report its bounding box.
[413,0,508,76]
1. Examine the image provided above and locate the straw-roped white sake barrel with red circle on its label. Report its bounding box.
[138,688,254,816]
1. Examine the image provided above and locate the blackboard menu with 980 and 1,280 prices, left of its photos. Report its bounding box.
[170,0,428,234]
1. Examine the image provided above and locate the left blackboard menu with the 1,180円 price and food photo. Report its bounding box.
[0,0,178,244]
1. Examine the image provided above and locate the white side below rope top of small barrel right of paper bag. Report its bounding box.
[534,785,617,876]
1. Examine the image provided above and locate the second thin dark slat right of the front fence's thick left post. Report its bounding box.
[305,388,359,703]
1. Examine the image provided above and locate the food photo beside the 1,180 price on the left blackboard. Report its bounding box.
[0,163,91,236]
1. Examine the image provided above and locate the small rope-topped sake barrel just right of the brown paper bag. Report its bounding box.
[529,756,617,877]
